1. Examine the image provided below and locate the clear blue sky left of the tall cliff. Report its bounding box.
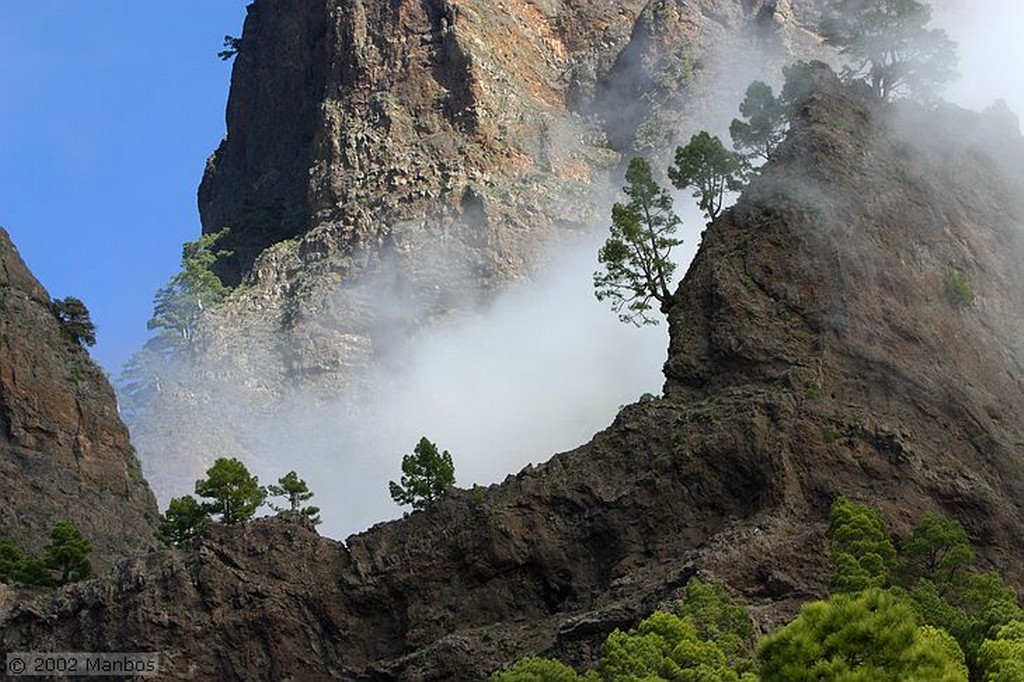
[0,0,247,371]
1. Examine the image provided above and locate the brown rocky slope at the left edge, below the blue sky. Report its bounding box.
[0,229,157,570]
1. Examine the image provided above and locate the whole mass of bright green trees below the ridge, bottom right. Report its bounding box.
[493,498,1024,682]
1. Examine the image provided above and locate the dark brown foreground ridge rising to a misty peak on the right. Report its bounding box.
[8,67,1024,680]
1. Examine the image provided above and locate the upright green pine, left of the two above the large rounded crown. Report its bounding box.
[825,498,896,592]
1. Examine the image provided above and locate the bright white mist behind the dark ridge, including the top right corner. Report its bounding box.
[134,0,1024,538]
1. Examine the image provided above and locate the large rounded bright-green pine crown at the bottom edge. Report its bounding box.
[758,588,967,682]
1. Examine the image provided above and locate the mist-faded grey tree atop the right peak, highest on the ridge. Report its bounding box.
[820,0,956,100]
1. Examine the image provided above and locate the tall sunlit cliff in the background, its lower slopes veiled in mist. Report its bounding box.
[132,0,818,507]
